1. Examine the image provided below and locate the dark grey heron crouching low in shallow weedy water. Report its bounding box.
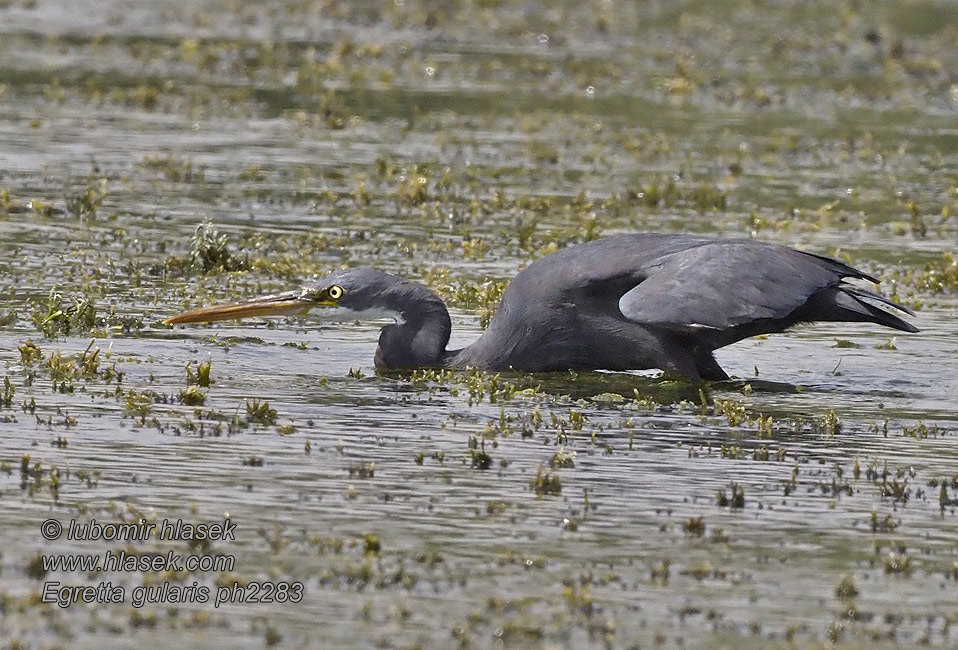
[166,234,918,380]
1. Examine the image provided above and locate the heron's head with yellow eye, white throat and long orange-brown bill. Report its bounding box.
[165,268,407,325]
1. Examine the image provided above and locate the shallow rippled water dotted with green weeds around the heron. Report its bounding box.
[0,0,958,648]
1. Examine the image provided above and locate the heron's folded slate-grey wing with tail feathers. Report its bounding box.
[619,235,918,342]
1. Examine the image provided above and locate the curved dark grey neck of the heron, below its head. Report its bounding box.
[375,282,452,370]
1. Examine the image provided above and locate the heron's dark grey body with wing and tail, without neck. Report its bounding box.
[454,233,917,378]
